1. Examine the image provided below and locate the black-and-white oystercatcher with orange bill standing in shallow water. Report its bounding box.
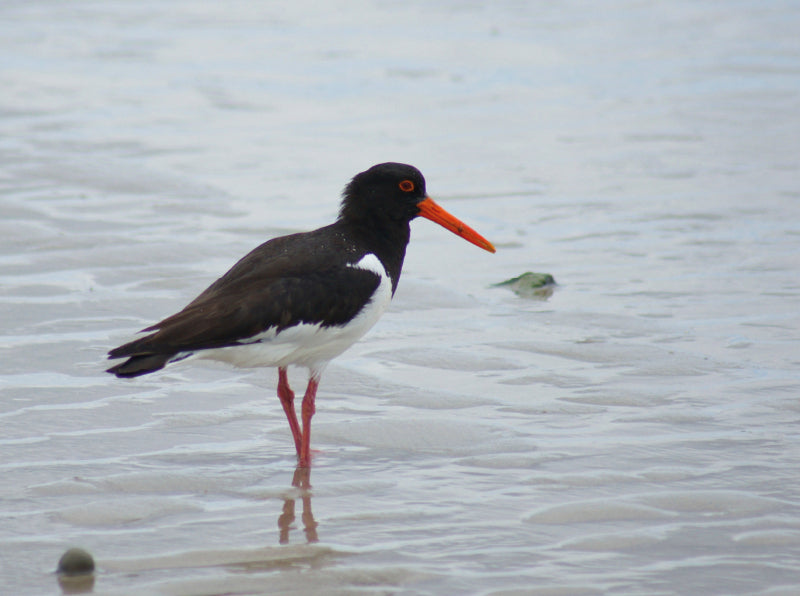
[108,163,495,467]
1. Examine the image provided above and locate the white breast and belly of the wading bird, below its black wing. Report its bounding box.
[197,253,392,373]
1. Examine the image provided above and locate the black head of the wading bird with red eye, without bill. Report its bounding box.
[339,162,427,223]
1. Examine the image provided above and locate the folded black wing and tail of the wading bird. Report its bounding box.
[109,230,380,376]
